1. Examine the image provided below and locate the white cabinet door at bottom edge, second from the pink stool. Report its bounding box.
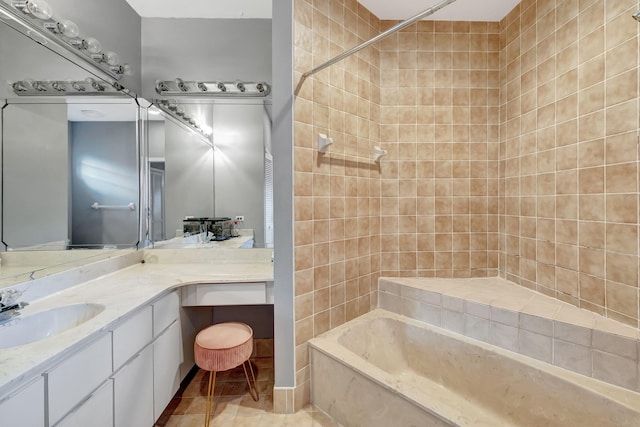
[113,345,154,427]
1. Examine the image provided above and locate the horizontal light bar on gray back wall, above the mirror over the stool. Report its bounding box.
[156,79,271,97]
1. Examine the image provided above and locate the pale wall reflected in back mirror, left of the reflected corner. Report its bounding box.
[164,120,214,238]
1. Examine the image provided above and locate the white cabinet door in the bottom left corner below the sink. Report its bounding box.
[0,377,44,427]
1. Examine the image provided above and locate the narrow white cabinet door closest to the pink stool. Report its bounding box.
[153,321,182,420]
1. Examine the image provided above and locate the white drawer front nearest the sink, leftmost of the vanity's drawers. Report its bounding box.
[45,334,112,424]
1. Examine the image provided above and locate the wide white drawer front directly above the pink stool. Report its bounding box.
[182,282,267,306]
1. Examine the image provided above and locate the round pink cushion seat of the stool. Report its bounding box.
[194,322,253,372]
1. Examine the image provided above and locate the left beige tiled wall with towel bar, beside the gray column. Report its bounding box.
[294,0,380,407]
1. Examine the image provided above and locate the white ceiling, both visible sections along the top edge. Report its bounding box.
[126,0,520,21]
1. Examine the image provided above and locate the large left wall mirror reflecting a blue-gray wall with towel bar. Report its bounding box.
[0,8,140,286]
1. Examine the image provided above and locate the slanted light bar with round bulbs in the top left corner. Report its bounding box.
[0,0,133,80]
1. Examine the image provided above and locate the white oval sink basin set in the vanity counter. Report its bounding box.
[0,304,104,349]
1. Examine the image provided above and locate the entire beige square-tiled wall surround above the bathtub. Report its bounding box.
[294,0,640,414]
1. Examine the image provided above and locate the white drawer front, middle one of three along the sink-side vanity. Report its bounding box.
[113,306,153,371]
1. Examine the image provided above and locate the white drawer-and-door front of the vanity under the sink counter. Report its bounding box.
[0,291,182,427]
